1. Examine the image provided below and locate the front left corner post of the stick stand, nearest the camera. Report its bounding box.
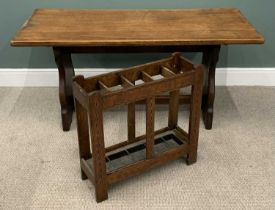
[89,92,108,202]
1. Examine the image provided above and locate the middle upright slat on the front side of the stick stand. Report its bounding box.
[146,97,155,159]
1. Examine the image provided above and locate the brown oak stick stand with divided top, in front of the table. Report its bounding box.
[73,53,203,202]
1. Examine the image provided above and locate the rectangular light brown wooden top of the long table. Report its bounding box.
[11,8,264,46]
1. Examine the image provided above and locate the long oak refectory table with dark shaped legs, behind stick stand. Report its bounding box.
[11,8,264,131]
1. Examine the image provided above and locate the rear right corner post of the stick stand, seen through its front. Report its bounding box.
[168,90,180,129]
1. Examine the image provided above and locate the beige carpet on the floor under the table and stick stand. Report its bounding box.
[0,87,275,210]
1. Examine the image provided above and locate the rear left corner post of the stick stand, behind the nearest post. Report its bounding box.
[75,98,92,180]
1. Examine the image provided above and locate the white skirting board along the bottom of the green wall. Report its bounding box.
[0,67,275,87]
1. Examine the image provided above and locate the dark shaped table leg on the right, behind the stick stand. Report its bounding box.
[202,45,221,129]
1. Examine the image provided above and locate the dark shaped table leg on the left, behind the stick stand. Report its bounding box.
[53,47,74,131]
